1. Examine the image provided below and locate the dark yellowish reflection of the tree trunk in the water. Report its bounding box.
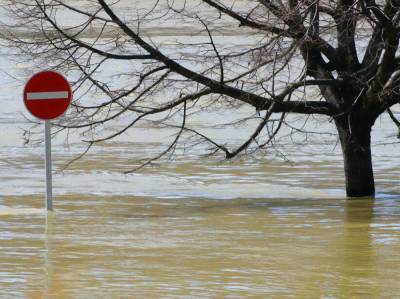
[337,199,381,298]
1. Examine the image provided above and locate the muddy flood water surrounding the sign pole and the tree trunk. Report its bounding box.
[0,1,400,298]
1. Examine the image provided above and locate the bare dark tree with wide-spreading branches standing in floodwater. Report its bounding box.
[7,0,400,197]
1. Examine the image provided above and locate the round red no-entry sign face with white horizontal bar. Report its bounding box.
[24,71,72,120]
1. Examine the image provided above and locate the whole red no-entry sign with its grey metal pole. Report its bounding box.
[24,71,72,210]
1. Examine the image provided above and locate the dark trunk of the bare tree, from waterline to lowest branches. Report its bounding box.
[336,122,375,197]
